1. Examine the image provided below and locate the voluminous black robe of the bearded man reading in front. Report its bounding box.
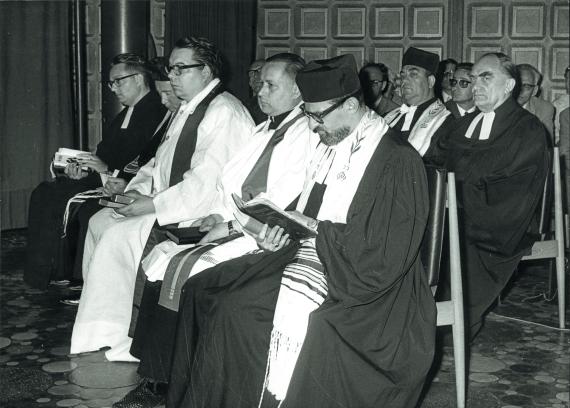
[167,129,436,408]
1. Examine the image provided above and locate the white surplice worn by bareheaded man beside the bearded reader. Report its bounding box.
[143,106,318,282]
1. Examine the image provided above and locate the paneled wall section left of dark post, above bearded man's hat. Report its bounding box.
[257,0,452,79]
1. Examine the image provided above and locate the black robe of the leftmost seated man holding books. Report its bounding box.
[24,91,166,289]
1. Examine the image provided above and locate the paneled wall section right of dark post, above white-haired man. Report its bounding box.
[463,0,570,100]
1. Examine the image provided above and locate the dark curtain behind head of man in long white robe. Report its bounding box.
[165,0,257,100]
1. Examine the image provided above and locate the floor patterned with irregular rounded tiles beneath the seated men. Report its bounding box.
[0,231,570,408]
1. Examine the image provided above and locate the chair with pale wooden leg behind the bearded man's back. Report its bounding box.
[421,167,466,408]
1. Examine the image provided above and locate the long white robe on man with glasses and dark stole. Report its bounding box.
[71,79,254,361]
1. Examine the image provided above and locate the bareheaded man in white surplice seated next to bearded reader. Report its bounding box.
[114,53,318,408]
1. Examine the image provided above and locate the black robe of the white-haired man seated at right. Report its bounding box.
[424,98,550,336]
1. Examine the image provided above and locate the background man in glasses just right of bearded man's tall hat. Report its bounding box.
[358,62,398,116]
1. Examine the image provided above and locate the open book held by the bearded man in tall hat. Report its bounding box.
[232,194,317,240]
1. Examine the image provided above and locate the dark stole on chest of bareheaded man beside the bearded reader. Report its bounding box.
[241,113,303,201]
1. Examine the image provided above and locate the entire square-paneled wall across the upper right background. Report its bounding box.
[257,0,569,99]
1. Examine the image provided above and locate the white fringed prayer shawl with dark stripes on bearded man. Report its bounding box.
[259,110,388,407]
